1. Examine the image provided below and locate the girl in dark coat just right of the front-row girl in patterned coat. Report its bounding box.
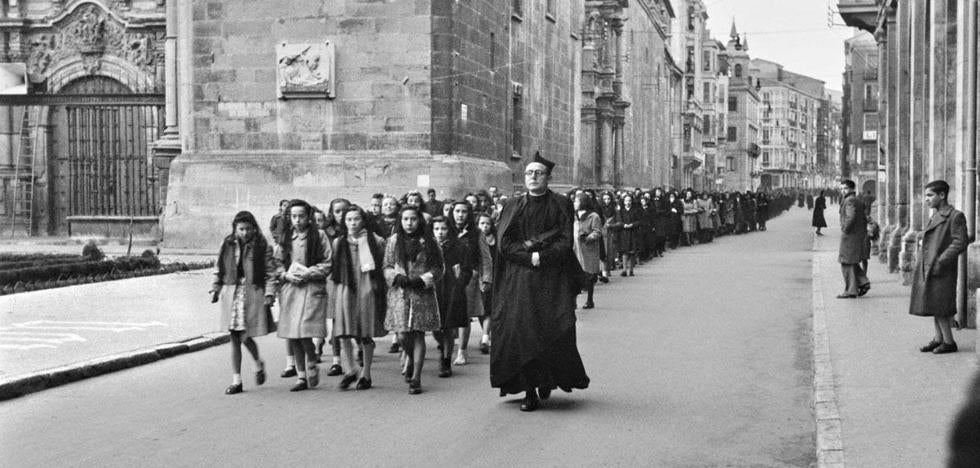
[432,218,475,377]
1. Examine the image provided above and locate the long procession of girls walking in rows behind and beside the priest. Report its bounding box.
[210,178,795,394]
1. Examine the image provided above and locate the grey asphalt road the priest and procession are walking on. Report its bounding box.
[0,209,816,467]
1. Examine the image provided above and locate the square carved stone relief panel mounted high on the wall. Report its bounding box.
[276,41,336,99]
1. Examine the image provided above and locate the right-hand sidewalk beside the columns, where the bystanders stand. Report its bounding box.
[813,226,977,468]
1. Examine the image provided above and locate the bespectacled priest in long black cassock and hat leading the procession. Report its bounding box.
[490,153,589,411]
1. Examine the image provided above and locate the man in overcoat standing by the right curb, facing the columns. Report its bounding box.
[837,179,871,299]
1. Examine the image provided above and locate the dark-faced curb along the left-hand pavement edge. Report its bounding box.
[0,333,231,401]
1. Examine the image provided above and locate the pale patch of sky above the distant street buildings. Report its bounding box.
[703,0,855,91]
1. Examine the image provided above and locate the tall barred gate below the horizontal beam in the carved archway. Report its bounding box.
[65,104,163,216]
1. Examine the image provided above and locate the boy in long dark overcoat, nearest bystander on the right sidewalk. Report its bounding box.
[909,180,970,354]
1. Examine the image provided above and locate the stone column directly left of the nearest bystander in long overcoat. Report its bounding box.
[899,2,933,285]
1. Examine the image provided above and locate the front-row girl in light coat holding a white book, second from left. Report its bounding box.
[275,200,332,392]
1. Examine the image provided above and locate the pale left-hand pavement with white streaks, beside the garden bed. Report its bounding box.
[0,268,227,400]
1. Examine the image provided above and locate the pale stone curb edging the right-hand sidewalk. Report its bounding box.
[811,236,846,468]
